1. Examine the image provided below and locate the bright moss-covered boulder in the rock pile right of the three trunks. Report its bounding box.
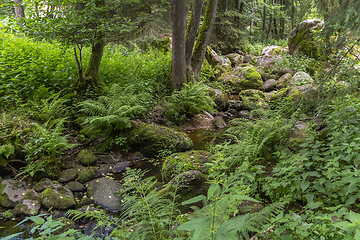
[218,64,264,94]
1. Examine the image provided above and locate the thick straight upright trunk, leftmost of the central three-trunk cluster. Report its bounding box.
[171,0,186,90]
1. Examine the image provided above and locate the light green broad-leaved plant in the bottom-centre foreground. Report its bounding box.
[177,173,283,240]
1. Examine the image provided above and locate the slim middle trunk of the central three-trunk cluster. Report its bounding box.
[185,0,203,67]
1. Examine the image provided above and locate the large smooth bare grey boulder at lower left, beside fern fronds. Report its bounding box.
[87,178,121,212]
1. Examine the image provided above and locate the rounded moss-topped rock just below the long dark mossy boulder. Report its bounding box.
[161,150,215,182]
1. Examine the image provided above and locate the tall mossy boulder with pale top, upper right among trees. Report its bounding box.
[288,19,324,59]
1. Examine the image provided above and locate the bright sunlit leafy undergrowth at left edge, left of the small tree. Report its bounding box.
[0,33,76,108]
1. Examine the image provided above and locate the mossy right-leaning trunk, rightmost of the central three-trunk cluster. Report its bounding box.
[191,0,218,78]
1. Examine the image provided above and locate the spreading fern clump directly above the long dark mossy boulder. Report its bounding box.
[78,84,147,133]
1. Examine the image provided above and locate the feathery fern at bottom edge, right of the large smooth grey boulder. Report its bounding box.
[112,169,179,239]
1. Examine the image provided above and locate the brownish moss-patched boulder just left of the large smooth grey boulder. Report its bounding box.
[40,184,75,210]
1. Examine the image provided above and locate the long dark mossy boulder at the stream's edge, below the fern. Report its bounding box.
[128,121,193,157]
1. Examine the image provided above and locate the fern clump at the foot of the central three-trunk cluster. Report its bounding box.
[165,82,215,124]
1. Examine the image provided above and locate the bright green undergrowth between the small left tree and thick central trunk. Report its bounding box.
[99,45,172,97]
